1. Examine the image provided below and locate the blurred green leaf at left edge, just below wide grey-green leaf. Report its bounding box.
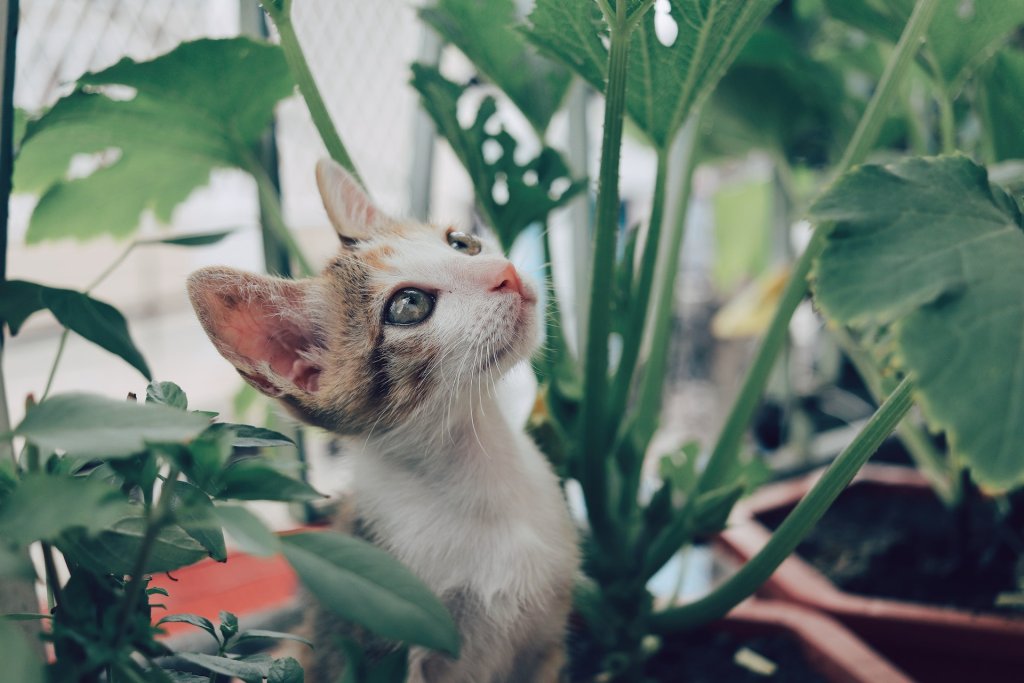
[0,474,126,546]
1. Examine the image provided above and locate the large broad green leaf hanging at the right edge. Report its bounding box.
[813,156,1024,490]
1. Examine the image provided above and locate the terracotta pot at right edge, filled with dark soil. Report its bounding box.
[716,465,1024,683]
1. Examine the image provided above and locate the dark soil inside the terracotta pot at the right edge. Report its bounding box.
[758,484,1024,617]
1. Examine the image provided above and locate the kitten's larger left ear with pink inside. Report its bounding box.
[188,267,322,399]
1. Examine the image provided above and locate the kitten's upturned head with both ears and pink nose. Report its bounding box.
[188,160,537,433]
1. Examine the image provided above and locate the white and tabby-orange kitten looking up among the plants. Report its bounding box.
[188,160,579,683]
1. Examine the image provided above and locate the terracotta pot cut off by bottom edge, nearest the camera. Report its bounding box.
[712,599,911,683]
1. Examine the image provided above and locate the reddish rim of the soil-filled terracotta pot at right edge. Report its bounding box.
[716,465,1024,654]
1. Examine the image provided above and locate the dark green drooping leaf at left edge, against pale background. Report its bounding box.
[0,280,151,379]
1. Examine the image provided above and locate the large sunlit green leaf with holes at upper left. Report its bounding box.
[14,38,292,242]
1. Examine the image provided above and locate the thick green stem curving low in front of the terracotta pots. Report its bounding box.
[651,379,913,633]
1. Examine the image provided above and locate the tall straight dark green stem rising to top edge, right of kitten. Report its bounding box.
[580,2,629,548]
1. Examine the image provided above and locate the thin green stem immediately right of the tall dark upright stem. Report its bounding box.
[608,148,669,428]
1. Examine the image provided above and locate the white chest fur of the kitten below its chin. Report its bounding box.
[353,389,578,620]
